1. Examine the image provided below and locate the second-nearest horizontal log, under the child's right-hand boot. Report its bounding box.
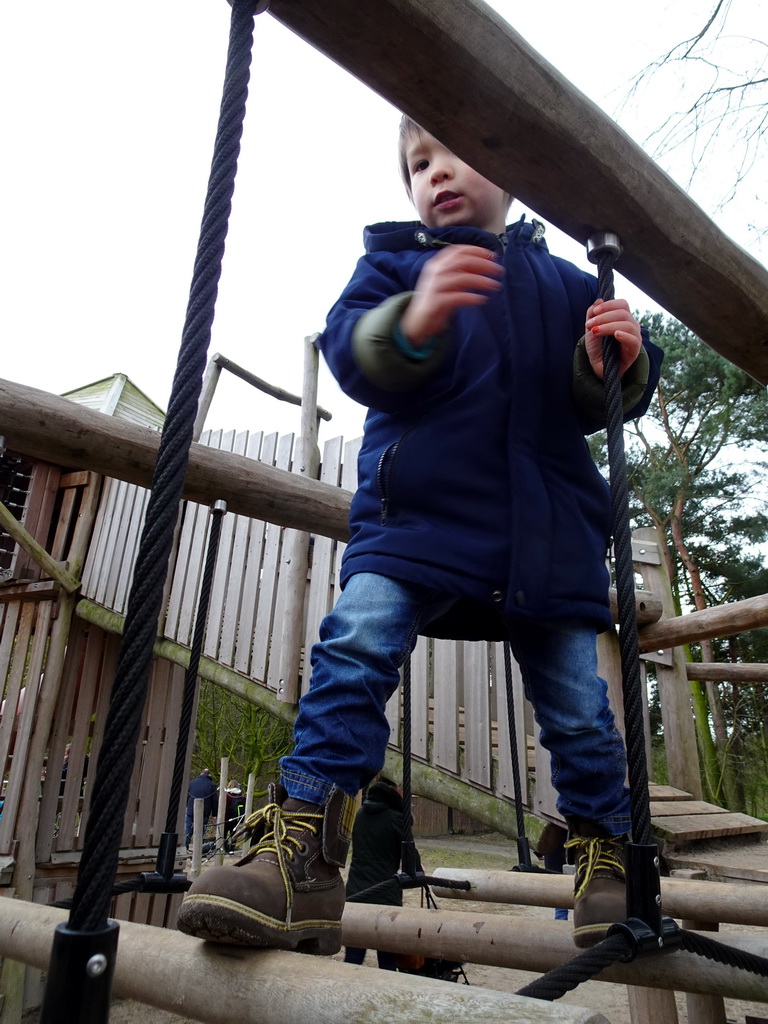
[342,903,768,1007]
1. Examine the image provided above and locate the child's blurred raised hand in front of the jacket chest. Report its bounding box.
[400,246,504,347]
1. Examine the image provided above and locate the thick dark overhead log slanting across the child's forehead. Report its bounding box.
[269,0,768,384]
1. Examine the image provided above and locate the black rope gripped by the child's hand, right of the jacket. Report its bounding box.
[597,252,651,844]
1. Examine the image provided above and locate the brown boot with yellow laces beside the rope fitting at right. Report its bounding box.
[565,819,627,949]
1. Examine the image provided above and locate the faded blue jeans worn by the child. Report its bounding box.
[281,572,630,836]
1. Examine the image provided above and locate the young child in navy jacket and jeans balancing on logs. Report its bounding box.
[178,118,660,953]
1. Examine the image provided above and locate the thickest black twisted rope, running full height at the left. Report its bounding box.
[69,0,258,931]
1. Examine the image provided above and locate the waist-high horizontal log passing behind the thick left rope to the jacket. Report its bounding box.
[0,379,351,541]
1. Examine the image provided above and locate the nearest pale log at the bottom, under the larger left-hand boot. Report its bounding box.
[0,898,607,1024]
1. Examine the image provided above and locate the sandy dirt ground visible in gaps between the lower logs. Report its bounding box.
[25,835,768,1024]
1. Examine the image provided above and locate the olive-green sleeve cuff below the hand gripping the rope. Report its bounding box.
[573,328,664,434]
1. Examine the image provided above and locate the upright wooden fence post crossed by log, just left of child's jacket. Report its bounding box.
[278,334,319,705]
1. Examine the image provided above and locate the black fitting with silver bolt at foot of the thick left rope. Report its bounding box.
[40,921,120,1024]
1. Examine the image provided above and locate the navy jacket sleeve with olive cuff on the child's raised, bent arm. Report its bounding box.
[318,254,450,412]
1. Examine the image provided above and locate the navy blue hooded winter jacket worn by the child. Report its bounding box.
[319,220,662,639]
